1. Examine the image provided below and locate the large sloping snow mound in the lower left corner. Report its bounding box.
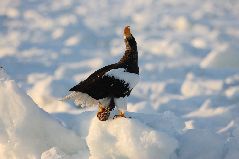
[0,69,86,159]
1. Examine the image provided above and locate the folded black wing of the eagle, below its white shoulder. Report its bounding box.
[70,63,131,100]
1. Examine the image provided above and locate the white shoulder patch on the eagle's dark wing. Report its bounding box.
[105,68,139,89]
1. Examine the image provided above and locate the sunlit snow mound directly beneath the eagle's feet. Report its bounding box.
[86,118,178,159]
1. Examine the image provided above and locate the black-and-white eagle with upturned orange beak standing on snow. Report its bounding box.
[62,26,139,121]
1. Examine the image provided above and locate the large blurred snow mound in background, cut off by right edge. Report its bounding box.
[200,45,239,68]
